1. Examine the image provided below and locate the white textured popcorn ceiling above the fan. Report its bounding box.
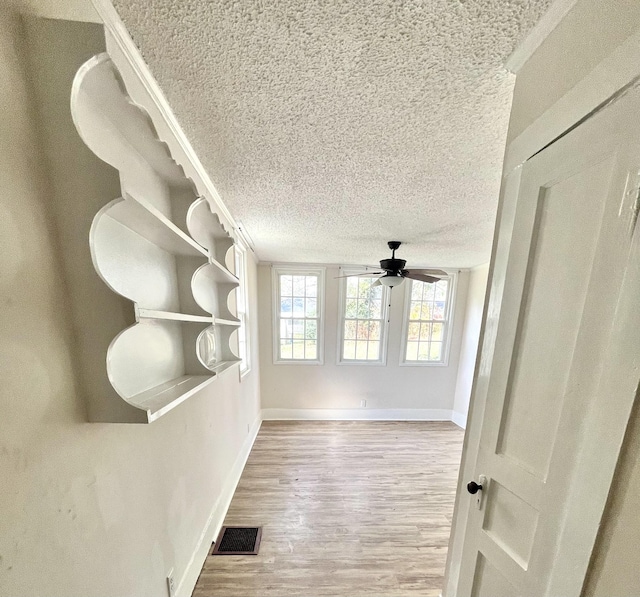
[114,0,550,267]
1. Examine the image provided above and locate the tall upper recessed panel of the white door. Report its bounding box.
[497,158,615,481]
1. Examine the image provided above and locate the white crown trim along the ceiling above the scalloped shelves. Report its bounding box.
[91,0,255,252]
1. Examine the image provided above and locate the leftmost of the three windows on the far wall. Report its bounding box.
[273,267,324,364]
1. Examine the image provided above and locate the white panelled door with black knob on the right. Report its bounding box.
[456,89,640,597]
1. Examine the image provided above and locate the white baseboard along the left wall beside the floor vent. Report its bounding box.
[176,414,262,597]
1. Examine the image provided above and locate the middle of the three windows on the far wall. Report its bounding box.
[340,271,389,364]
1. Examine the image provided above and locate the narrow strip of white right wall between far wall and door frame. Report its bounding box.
[453,263,489,428]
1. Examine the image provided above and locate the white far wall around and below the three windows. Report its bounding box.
[258,265,469,419]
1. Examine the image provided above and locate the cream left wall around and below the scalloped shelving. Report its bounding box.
[0,11,260,597]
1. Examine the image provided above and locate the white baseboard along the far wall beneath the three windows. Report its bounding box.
[262,408,452,421]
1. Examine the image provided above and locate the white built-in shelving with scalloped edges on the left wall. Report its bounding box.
[71,54,240,422]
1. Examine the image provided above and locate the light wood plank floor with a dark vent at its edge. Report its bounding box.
[193,421,463,597]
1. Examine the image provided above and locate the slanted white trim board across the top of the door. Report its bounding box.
[503,26,640,175]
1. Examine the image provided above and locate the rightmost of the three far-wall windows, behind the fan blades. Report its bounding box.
[403,277,454,365]
